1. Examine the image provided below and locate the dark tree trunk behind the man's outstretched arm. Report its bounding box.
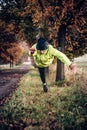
[56,24,66,81]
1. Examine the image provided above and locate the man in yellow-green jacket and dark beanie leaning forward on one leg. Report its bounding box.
[30,37,74,92]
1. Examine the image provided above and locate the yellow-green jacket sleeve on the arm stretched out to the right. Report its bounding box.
[51,46,71,66]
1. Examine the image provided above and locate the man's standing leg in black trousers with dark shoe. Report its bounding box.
[38,67,48,92]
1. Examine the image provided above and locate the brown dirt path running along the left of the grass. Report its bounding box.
[0,64,29,105]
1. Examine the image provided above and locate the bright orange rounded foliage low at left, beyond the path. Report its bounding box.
[0,42,24,67]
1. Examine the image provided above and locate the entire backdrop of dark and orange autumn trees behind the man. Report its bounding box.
[0,0,87,80]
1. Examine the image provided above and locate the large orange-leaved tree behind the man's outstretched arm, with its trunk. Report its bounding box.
[24,0,87,81]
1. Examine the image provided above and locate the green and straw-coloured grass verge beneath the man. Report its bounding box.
[0,64,87,130]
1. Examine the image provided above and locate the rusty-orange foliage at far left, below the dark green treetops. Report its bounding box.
[0,21,23,64]
